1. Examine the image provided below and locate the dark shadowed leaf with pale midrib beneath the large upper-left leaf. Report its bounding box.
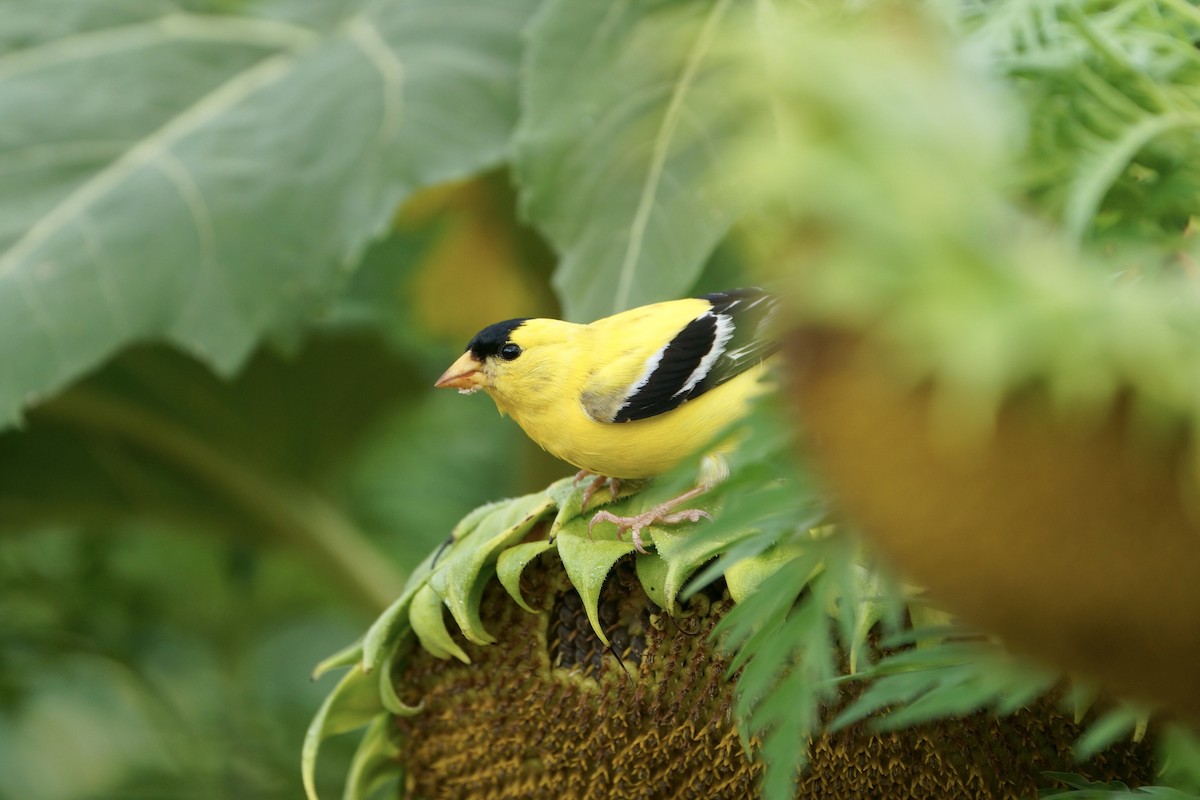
[0,336,417,613]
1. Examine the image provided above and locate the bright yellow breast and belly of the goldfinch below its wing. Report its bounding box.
[497,365,766,479]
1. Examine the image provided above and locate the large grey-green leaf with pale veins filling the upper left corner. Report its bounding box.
[0,0,533,425]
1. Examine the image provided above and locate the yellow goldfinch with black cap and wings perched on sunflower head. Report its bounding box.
[434,289,776,549]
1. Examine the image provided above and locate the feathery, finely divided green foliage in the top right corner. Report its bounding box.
[960,0,1200,247]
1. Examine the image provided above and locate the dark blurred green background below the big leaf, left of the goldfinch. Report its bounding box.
[0,174,569,800]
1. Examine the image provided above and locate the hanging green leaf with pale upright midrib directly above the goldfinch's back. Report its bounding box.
[515,0,736,320]
